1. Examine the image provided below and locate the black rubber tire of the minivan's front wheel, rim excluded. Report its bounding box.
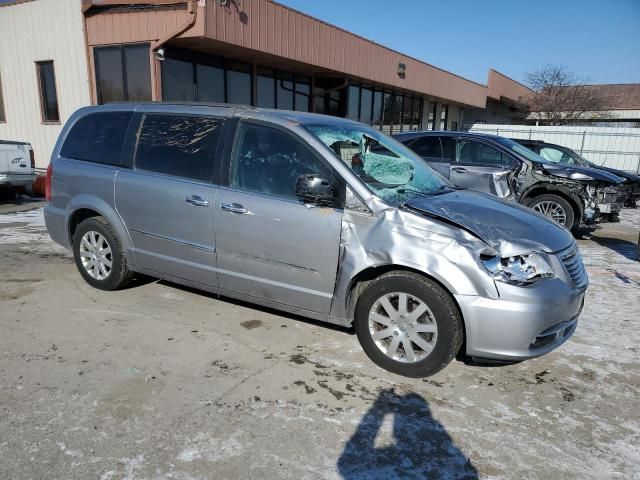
[354,271,464,378]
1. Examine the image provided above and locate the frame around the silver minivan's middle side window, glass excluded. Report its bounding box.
[131,110,229,186]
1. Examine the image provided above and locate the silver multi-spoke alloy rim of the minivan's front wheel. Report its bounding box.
[369,292,438,363]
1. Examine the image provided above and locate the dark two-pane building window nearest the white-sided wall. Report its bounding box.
[93,44,151,104]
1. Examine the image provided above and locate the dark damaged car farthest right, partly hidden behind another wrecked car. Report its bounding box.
[513,138,640,208]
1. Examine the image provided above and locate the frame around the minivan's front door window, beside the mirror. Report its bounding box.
[225,119,349,210]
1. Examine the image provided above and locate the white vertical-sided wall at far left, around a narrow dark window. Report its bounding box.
[0,0,90,168]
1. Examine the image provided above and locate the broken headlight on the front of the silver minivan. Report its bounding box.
[481,253,554,285]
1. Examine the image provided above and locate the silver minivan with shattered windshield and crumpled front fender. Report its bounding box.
[45,103,588,377]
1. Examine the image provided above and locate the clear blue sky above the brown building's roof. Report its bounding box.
[278,0,640,83]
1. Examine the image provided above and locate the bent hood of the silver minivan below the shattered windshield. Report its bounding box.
[404,190,573,256]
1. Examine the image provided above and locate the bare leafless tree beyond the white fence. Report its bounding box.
[525,65,607,125]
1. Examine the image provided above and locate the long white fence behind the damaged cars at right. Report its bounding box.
[470,123,640,173]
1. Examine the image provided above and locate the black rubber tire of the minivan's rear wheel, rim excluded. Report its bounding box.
[73,217,133,291]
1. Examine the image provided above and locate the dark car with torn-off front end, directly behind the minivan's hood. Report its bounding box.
[395,132,623,230]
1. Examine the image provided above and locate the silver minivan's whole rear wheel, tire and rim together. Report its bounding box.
[73,217,133,291]
